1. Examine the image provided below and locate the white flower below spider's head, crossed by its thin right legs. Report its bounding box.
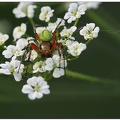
[45,55,67,78]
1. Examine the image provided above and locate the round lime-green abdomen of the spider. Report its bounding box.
[40,30,52,41]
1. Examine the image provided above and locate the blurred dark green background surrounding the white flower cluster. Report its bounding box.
[0,2,120,119]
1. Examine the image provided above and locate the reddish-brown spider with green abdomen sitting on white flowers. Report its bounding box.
[21,20,65,72]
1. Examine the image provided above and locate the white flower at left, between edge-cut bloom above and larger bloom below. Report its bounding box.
[2,45,23,59]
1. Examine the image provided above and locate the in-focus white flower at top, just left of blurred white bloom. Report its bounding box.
[64,3,87,23]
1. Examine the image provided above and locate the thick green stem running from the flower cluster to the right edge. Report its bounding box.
[66,70,120,86]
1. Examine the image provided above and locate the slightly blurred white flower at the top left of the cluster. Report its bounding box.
[13,2,37,18]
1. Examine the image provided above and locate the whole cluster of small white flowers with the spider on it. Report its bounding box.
[0,2,99,100]
